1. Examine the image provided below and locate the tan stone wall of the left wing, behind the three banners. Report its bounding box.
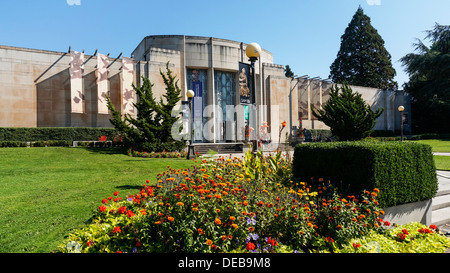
[0,46,125,127]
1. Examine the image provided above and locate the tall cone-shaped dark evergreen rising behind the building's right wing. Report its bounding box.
[329,7,397,90]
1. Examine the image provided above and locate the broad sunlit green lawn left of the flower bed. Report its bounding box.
[0,148,192,253]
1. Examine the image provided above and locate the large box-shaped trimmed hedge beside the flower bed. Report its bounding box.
[293,141,438,207]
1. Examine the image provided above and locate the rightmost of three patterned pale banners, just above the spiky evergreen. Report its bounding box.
[122,57,135,116]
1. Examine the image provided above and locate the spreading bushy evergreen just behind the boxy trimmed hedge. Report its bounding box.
[311,83,384,141]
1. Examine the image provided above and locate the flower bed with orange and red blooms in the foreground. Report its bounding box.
[60,152,450,253]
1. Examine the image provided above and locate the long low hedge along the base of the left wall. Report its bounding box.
[0,127,118,142]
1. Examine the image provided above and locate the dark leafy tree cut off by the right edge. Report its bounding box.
[401,24,450,133]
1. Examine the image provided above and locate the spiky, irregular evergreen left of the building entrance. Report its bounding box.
[107,63,185,152]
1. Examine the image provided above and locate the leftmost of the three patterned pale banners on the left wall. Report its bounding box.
[69,51,84,113]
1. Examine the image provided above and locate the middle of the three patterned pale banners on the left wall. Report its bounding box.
[97,54,110,114]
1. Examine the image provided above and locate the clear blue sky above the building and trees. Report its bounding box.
[0,0,450,88]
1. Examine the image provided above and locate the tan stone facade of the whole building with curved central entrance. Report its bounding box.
[0,35,410,143]
